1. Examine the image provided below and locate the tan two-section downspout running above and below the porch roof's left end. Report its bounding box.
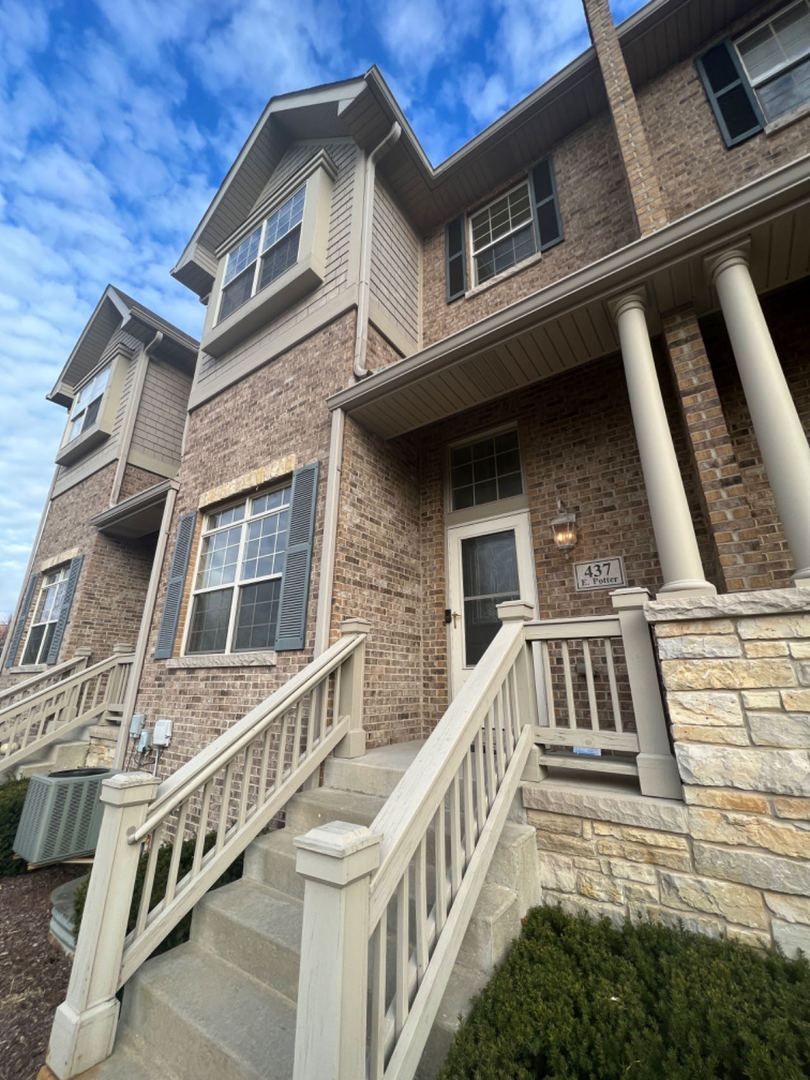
[314,121,402,657]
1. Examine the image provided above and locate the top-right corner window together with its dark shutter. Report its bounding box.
[697,0,810,147]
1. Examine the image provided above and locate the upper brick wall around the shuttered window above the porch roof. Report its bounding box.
[422,112,638,346]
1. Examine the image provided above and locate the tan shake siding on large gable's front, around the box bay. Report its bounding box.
[192,140,357,404]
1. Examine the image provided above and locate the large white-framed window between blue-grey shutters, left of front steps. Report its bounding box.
[186,486,291,654]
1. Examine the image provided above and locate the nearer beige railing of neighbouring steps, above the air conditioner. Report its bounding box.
[0,651,133,773]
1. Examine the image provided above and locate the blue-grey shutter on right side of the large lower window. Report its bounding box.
[275,461,319,652]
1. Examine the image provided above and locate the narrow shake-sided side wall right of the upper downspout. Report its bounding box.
[370,181,421,352]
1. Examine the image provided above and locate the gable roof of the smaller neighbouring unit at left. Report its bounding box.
[48,285,200,406]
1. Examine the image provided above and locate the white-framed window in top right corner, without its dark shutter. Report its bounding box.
[735,0,810,121]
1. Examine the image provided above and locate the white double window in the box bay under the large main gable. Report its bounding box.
[219,188,306,321]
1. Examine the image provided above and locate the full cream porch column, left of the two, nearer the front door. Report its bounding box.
[612,292,716,595]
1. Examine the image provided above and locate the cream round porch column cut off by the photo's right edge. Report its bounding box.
[706,244,810,585]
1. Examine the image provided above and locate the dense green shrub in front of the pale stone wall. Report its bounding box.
[440,908,810,1080]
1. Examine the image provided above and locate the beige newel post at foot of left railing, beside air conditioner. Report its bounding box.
[46,772,158,1080]
